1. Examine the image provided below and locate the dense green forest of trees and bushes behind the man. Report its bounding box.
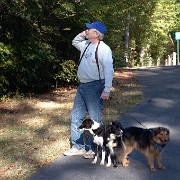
[0,0,180,97]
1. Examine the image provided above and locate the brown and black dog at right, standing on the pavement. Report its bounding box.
[117,127,170,171]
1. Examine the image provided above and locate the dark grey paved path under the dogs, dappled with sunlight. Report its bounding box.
[30,66,180,180]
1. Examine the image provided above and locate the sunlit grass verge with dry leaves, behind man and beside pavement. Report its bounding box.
[0,70,143,180]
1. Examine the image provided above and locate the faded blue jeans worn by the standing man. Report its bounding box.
[71,80,104,149]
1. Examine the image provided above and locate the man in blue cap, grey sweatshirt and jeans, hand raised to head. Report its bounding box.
[64,21,114,158]
